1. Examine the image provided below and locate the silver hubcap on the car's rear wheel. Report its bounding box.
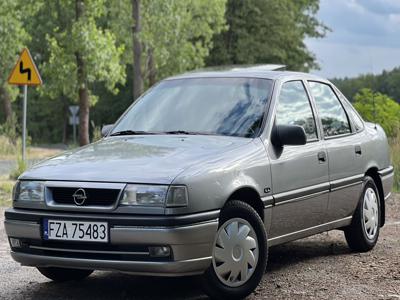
[363,188,379,240]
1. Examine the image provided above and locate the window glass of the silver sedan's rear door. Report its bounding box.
[309,81,351,136]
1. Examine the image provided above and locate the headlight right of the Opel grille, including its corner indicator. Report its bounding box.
[121,184,187,207]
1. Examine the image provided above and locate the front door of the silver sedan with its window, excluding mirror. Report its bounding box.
[268,80,329,239]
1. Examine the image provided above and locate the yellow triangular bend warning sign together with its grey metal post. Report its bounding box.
[8,48,42,162]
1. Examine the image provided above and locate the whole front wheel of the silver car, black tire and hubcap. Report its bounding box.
[202,200,268,299]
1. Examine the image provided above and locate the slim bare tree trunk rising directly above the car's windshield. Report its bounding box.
[132,0,143,100]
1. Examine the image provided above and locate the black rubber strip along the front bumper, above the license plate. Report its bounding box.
[5,208,219,226]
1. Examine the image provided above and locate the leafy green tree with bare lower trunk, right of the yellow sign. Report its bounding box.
[36,0,125,145]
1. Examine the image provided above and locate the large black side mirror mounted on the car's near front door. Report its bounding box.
[271,125,307,147]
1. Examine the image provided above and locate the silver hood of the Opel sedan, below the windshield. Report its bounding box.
[20,135,251,184]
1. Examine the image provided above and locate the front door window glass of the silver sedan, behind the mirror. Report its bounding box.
[275,81,317,141]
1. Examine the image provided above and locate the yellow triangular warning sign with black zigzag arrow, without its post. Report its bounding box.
[8,48,42,85]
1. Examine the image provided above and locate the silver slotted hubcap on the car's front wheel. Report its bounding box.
[212,218,259,287]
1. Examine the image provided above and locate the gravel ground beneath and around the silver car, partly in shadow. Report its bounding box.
[0,195,400,299]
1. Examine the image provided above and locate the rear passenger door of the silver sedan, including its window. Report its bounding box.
[308,81,364,222]
